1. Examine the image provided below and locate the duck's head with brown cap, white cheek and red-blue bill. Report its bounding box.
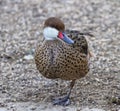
[43,17,74,44]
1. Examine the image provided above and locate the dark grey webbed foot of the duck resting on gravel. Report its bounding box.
[53,95,70,106]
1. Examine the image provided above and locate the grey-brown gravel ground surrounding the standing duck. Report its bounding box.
[0,0,120,111]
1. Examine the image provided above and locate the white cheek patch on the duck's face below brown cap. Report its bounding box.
[43,27,59,40]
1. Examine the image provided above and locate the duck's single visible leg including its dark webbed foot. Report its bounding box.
[53,80,75,106]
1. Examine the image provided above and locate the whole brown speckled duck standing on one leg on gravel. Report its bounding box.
[35,17,91,106]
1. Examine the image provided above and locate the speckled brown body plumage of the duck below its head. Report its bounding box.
[35,32,89,80]
